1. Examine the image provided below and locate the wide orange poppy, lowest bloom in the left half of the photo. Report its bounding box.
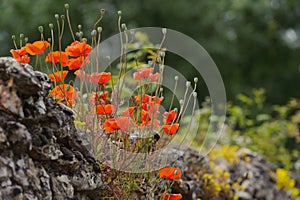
[103,117,130,133]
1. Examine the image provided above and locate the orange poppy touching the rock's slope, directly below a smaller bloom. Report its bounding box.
[50,84,76,100]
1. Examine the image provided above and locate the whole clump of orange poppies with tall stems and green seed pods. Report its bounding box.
[11,4,197,200]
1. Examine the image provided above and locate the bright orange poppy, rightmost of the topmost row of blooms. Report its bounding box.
[65,41,92,57]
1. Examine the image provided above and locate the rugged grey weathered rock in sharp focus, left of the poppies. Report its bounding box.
[0,58,104,200]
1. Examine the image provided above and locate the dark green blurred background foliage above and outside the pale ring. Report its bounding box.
[0,0,300,104]
